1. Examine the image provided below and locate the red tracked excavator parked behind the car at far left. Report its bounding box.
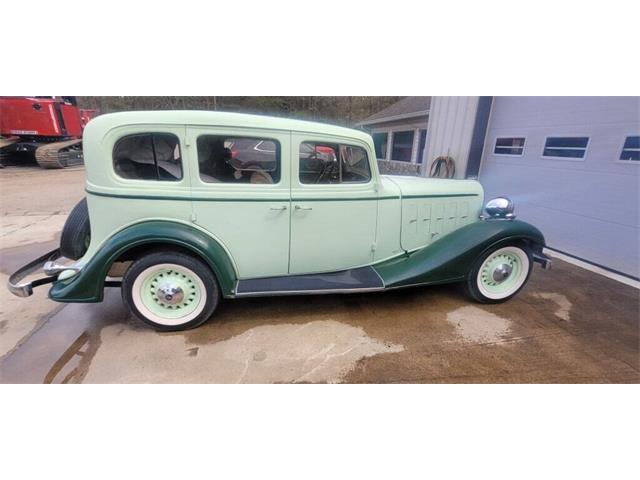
[0,97,97,168]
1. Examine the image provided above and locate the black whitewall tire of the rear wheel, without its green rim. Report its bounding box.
[122,251,220,332]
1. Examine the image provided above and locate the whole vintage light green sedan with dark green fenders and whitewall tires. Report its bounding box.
[9,112,549,331]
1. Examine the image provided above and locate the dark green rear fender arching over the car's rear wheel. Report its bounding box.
[49,221,236,302]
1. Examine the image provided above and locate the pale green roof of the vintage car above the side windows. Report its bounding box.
[87,110,371,141]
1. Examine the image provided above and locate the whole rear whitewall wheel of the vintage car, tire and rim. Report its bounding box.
[122,252,220,331]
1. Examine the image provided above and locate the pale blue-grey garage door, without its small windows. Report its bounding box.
[480,97,640,277]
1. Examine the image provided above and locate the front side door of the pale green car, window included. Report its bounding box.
[289,133,378,274]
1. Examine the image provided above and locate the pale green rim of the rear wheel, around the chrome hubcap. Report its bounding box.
[139,265,202,319]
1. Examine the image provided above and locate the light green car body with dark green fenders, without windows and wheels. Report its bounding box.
[50,111,544,301]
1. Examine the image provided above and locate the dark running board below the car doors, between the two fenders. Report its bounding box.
[235,267,384,297]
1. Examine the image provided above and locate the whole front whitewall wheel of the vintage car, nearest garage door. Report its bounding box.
[466,245,533,303]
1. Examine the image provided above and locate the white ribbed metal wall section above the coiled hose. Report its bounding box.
[424,97,479,178]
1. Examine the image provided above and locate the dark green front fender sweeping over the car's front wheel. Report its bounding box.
[373,220,545,288]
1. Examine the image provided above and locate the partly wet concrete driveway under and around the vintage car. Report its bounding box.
[0,167,640,383]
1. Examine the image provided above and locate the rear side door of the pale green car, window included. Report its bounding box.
[187,126,291,279]
